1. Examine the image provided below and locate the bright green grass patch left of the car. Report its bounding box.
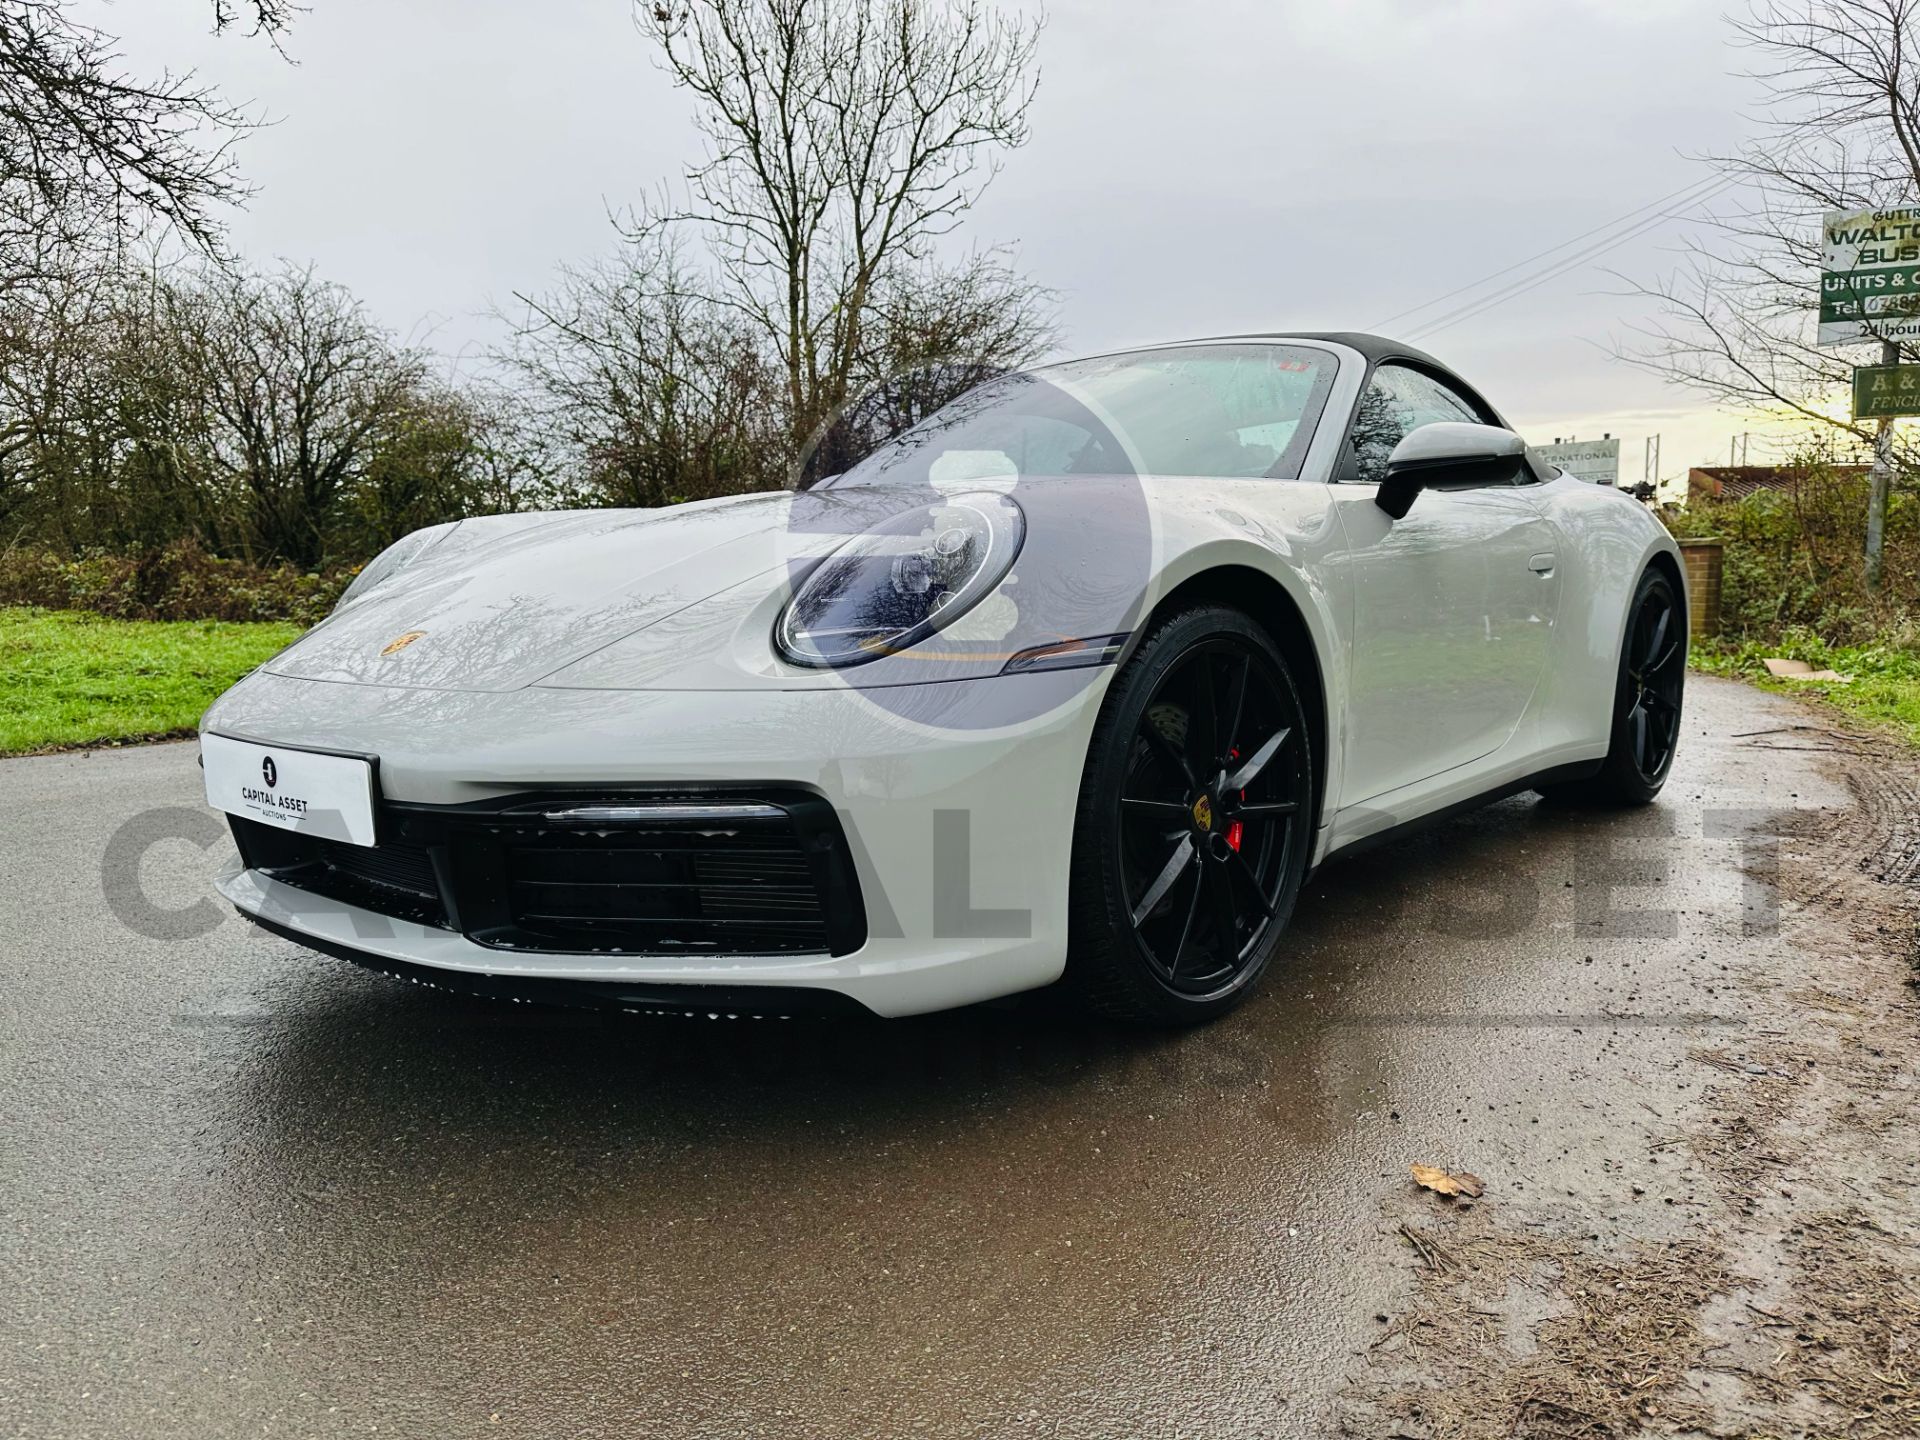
[0,609,300,755]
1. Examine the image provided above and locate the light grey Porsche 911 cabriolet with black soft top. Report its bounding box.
[200,334,1686,1023]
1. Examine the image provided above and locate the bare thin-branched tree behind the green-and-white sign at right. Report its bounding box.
[1624,0,1920,584]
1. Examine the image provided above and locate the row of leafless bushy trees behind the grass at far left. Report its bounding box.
[0,251,526,568]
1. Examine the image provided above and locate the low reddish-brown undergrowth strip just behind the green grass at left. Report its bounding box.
[0,540,355,626]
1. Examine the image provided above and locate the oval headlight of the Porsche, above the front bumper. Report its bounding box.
[774,492,1027,668]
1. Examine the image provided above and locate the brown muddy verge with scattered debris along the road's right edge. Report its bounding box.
[1344,695,1920,1440]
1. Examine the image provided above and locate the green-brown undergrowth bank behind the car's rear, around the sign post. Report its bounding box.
[1665,463,1920,645]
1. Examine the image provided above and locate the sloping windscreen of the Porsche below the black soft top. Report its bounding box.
[831,344,1338,486]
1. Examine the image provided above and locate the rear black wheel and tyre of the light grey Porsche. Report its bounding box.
[1540,568,1686,806]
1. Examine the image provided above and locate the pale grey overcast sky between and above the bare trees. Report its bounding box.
[79,0,1761,482]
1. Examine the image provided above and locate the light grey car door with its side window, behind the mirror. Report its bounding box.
[1331,361,1559,808]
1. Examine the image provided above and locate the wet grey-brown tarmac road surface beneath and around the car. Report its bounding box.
[0,678,1845,1438]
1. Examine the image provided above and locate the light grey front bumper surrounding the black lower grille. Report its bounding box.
[204,670,1112,1016]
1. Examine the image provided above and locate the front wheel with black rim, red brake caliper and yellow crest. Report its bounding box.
[1066,605,1313,1025]
